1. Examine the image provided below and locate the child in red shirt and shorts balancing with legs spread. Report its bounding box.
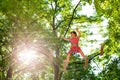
[58,28,103,72]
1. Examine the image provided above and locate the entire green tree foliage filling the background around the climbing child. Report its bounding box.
[0,0,120,80]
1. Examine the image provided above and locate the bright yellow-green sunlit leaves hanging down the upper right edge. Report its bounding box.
[94,0,120,74]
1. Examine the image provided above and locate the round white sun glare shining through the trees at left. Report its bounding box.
[18,48,37,64]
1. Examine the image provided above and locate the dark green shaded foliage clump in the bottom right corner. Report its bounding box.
[100,58,120,80]
